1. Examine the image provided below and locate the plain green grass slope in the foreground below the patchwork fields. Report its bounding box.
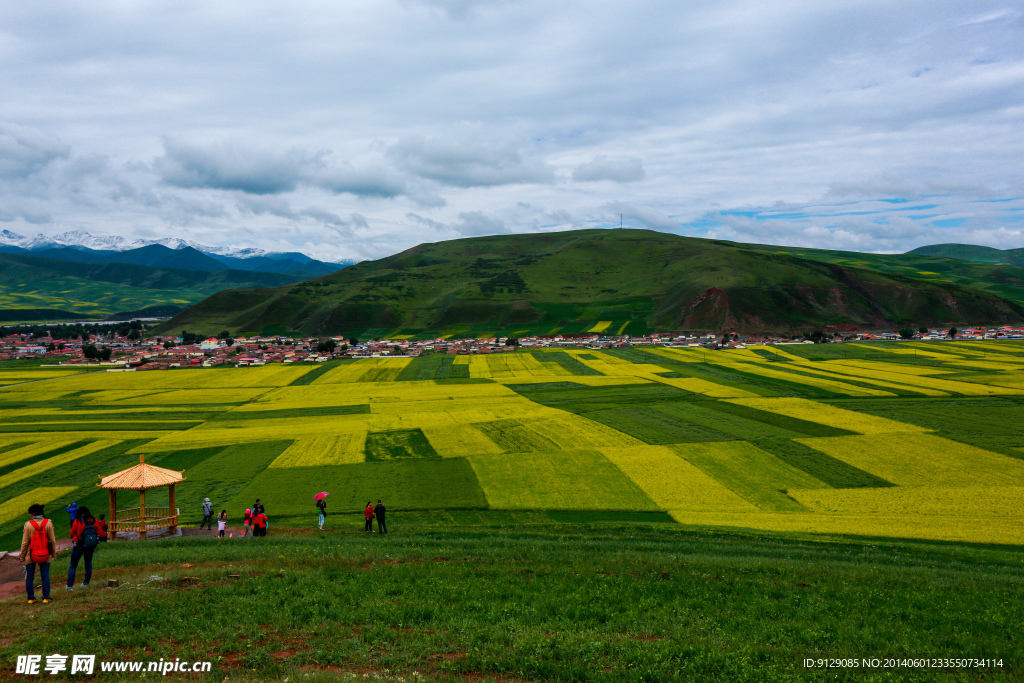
[0,516,1024,682]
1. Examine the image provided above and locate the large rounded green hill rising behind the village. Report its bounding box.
[157,229,1024,337]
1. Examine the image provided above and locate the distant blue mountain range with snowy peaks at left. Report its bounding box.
[0,230,353,278]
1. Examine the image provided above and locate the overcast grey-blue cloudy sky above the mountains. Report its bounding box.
[0,0,1024,259]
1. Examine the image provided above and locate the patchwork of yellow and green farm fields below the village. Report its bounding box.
[0,342,1024,549]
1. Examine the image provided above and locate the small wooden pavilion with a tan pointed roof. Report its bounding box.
[96,456,185,541]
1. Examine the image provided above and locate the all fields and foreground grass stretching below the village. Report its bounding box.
[0,342,1024,683]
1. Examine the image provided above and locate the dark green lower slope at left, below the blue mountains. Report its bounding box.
[0,253,296,322]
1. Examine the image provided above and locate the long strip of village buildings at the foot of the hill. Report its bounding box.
[0,326,1024,370]
